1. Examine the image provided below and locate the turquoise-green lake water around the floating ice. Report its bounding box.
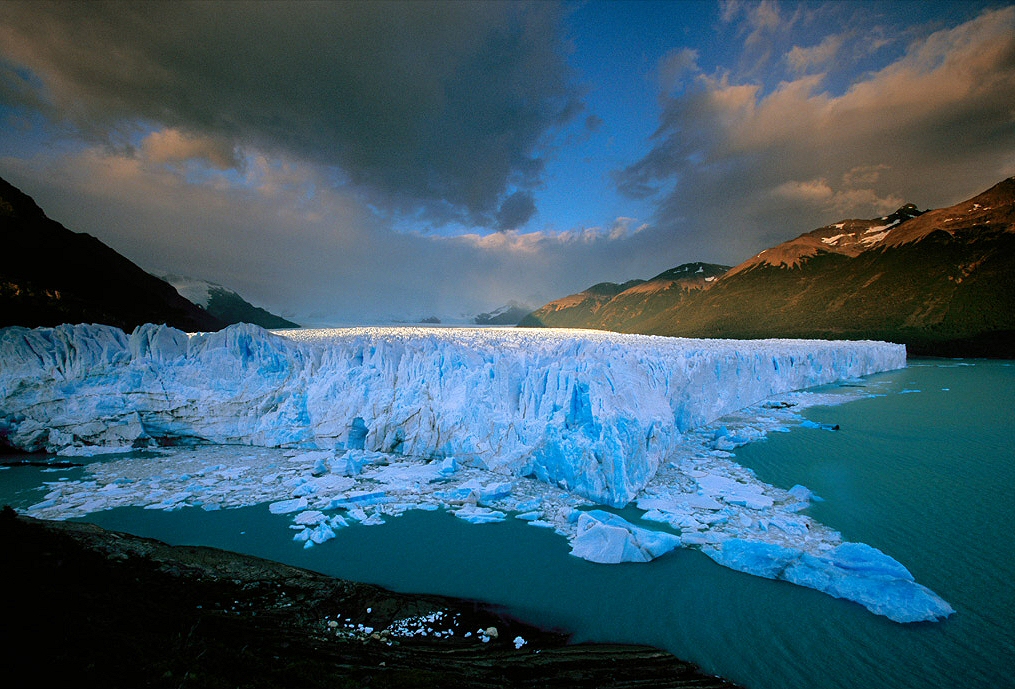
[0,359,1015,689]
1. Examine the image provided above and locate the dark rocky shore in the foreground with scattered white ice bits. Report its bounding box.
[0,507,733,688]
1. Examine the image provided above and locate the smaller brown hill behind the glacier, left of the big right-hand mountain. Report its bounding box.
[519,263,728,333]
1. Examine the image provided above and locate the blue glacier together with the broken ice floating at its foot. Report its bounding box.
[0,325,952,621]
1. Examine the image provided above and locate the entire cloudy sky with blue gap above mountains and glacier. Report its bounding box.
[0,0,1015,326]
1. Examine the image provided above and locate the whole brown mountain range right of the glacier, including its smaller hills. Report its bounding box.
[522,178,1015,358]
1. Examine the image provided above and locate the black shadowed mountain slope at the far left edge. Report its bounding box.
[0,175,224,331]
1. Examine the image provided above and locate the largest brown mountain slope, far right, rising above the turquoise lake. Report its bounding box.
[644,180,1015,357]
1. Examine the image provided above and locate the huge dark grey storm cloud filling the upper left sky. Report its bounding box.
[0,2,582,223]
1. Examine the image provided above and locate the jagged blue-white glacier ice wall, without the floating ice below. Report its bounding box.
[0,325,905,505]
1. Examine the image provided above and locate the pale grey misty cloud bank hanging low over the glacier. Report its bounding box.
[0,154,658,326]
